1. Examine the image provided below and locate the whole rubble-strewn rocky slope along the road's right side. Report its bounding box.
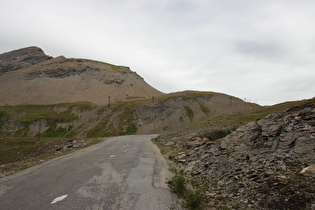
[158,99,315,209]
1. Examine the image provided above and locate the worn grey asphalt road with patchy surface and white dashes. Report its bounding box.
[0,135,177,210]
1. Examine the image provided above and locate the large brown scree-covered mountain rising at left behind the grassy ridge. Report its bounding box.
[0,47,162,105]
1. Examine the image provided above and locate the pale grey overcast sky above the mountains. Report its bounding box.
[0,0,315,105]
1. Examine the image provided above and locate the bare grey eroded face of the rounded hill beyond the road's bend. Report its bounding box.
[136,91,255,133]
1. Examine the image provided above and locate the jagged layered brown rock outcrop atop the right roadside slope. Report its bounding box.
[219,102,315,166]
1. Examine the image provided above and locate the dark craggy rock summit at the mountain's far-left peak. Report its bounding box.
[0,47,51,75]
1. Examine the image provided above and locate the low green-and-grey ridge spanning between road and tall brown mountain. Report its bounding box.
[0,91,257,137]
